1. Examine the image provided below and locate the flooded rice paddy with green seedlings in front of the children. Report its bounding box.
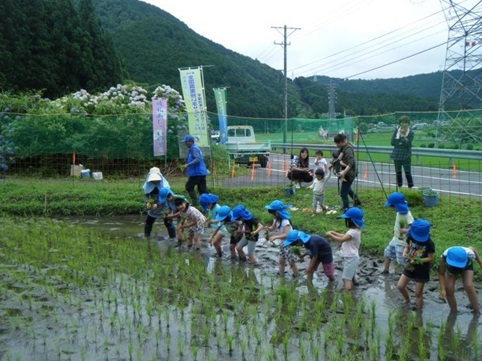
[0,216,482,361]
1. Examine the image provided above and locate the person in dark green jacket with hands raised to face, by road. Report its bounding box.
[390,115,413,188]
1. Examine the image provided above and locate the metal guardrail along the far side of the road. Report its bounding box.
[271,143,482,166]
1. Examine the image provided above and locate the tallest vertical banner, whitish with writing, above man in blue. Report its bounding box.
[179,67,209,147]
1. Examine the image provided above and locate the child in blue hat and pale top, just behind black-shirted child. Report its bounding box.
[382,192,413,274]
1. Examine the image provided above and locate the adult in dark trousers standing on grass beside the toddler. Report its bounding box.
[330,133,361,213]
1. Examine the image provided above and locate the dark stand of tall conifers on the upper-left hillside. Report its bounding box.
[0,0,126,97]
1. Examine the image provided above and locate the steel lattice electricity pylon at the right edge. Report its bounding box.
[438,0,482,144]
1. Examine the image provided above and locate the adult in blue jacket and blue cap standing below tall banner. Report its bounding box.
[181,135,208,206]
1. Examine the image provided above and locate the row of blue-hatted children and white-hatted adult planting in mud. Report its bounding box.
[143,168,482,313]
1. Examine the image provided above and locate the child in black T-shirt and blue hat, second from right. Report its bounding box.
[397,219,435,310]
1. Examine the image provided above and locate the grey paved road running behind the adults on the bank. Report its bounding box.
[217,154,482,198]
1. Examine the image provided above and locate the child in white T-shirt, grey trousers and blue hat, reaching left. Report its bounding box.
[326,207,365,291]
